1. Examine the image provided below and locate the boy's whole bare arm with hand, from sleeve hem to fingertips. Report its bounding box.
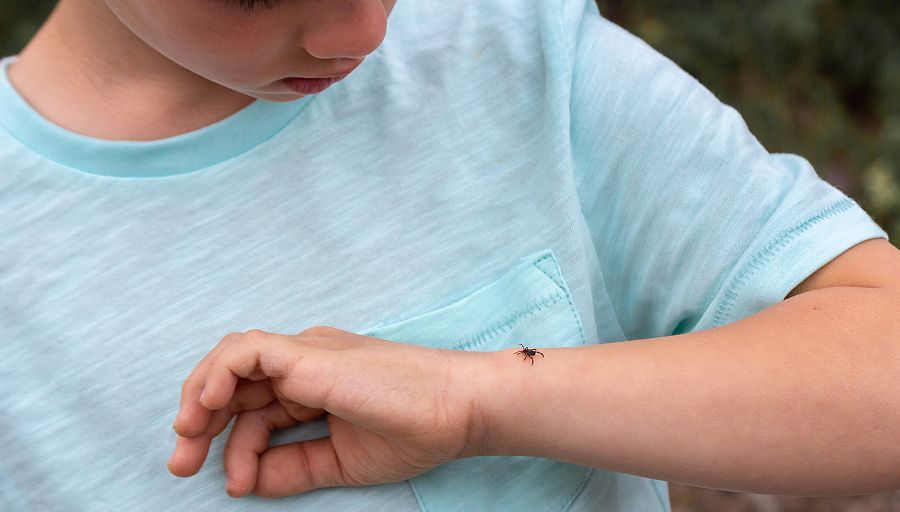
[169,239,900,497]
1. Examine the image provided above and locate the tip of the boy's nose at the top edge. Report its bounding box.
[300,0,390,59]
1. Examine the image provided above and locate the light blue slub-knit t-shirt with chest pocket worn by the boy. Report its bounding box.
[0,0,887,512]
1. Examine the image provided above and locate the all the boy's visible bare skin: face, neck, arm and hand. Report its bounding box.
[10,0,900,502]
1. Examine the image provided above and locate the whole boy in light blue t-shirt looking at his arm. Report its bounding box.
[0,0,900,511]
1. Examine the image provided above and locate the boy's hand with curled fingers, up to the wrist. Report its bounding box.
[169,327,479,497]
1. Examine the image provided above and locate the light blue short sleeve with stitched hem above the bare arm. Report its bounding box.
[561,4,888,339]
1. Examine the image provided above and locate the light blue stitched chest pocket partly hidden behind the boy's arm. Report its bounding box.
[358,249,591,512]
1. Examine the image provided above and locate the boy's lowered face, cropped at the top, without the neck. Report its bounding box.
[105,0,396,101]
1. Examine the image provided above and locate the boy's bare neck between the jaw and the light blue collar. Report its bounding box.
[8,0,253,140]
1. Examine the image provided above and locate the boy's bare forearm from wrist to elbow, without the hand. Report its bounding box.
[475,288,900,496]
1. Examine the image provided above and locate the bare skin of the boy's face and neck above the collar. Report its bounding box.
[9,0,395,140]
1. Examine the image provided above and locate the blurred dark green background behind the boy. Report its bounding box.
[0,0,900,512]
